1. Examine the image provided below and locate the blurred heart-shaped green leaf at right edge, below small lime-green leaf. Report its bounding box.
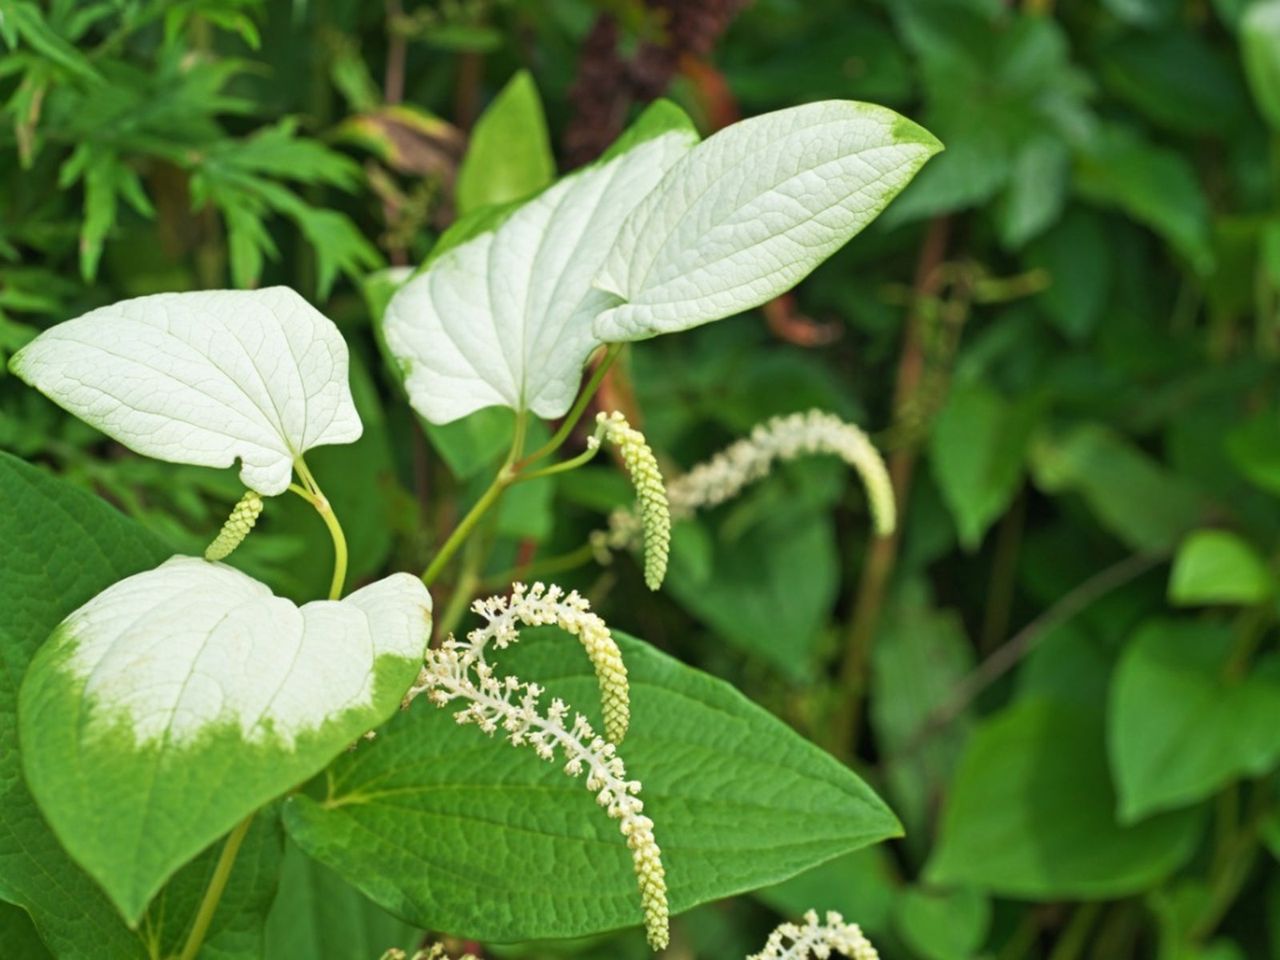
[1108,621,1280,822]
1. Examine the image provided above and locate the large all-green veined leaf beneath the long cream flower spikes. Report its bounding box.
[285,634,899,941]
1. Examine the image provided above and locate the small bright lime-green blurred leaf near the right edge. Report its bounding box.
[1169,530,1276,607]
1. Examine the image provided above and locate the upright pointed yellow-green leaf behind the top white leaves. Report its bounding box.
[454,70,556,214]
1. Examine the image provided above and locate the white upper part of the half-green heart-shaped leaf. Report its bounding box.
[55,557,431,748]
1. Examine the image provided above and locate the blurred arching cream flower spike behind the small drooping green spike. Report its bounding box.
[591,410,896,562]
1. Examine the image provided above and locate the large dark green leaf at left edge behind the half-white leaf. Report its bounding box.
[0,453,279,960]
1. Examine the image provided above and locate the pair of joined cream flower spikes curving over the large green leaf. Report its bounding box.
[404,584,669,950]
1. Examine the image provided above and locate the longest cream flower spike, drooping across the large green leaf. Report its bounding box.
[406,599,669,950]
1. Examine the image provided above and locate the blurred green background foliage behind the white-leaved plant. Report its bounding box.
[0,0,1280,960]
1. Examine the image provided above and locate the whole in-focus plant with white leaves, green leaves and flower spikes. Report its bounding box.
[0,80,941,960]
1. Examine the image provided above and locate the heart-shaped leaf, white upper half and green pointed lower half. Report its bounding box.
[19,557,431,924]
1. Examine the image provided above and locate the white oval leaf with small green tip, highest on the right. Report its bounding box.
[595,100,942,342]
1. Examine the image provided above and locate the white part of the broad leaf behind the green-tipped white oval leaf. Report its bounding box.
[384,131,696,424]
